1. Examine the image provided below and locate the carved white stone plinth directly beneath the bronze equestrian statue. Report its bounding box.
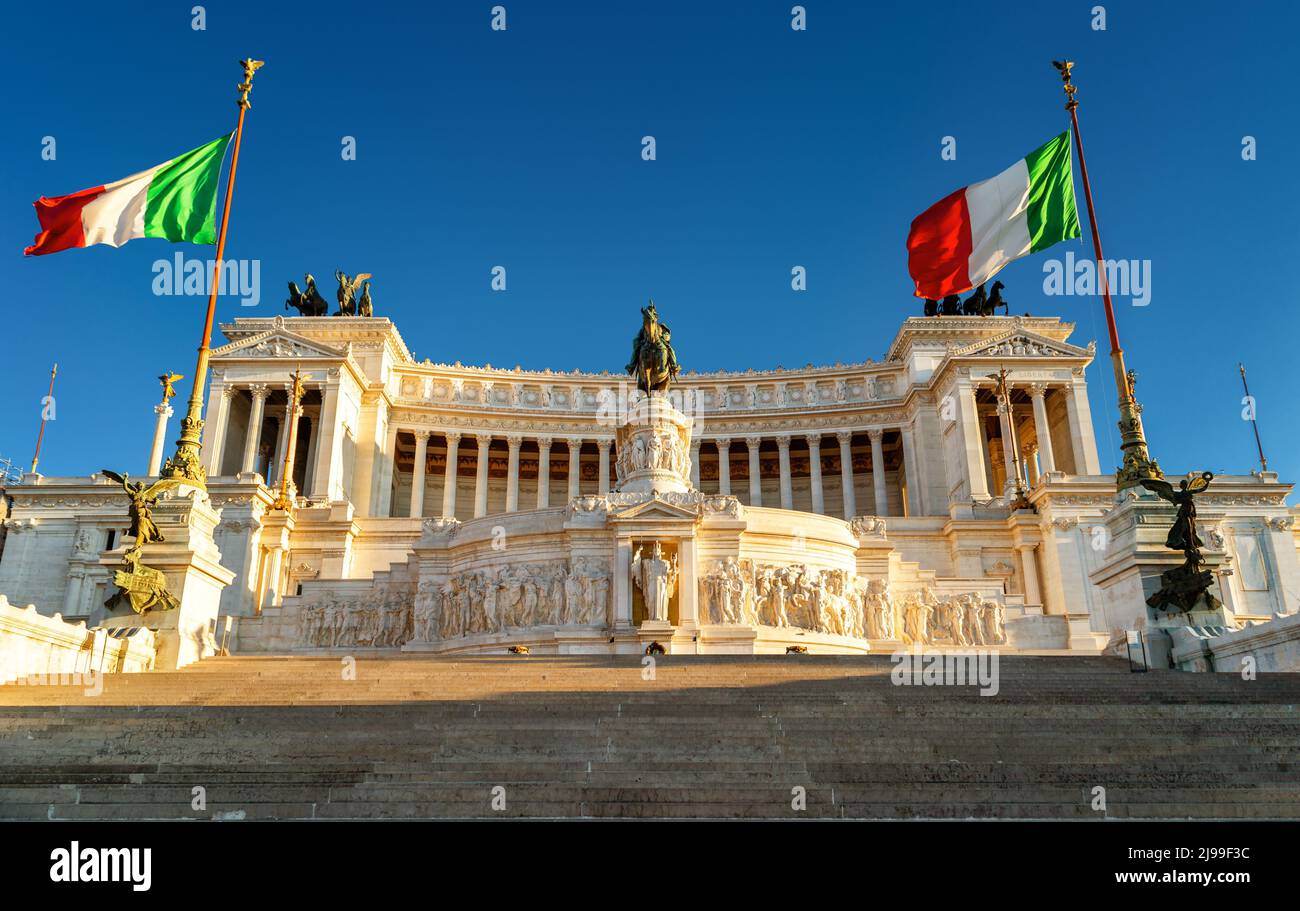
[614,394,693,494]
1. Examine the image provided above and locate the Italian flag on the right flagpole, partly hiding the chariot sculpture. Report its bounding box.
[907,131,1079,300]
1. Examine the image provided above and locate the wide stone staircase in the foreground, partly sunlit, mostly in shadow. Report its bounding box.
[0,655,1300,820]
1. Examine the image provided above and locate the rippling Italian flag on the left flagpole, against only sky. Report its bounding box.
[23,134,234,256]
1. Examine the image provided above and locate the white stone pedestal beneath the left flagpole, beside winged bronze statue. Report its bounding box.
[99,486,235,671]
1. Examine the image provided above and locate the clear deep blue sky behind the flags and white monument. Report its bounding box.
[0,0,1300,481]
